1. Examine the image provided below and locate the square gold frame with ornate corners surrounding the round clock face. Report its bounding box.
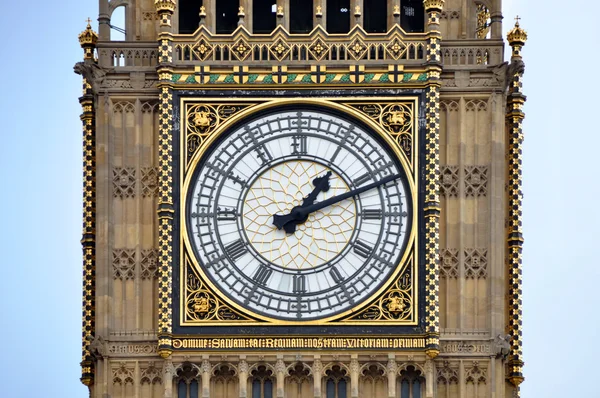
[175,95,420,326]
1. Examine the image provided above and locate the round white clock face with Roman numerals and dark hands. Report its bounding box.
[186,109,412,321]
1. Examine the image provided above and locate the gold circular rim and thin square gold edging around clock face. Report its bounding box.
[180,96,418,326]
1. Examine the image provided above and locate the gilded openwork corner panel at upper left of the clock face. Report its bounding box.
[185,103,252,163]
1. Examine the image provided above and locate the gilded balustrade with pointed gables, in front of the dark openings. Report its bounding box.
[173,24,427,67]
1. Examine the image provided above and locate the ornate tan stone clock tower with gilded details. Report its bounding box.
[75,0,527,398]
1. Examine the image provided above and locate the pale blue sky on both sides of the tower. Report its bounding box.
[0,0,600,398]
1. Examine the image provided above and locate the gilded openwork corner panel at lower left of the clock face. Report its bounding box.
[184,260,252,322]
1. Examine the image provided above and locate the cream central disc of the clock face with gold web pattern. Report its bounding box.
[242,160,356,269]
